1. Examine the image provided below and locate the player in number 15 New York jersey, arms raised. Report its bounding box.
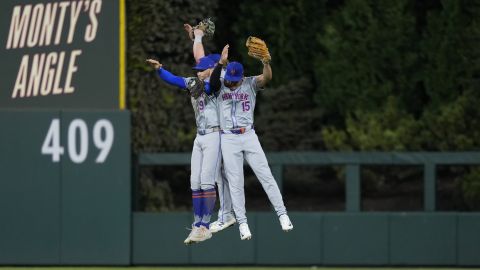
[210,45,293,240]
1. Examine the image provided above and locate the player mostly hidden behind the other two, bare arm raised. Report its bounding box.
[183,24,236,233]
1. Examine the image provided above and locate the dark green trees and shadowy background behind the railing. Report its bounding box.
[126,0,480,211]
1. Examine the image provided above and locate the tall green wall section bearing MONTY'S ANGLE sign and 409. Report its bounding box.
[0,0,132,265]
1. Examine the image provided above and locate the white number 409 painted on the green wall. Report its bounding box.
[42,118,114,163]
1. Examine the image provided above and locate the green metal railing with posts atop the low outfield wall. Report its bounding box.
[138,152,480,212]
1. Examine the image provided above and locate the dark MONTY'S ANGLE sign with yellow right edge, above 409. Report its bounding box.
[0,0,125,109]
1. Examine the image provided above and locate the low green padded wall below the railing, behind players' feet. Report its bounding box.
[132,212,480,266]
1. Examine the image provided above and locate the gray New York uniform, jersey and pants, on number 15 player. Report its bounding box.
[218,77,287,224]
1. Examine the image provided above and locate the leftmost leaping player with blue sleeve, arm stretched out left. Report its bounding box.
[146,57,221,244]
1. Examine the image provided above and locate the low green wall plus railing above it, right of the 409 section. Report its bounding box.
[132,152,480,266]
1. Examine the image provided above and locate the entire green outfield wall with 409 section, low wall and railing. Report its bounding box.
[0,134,480,266]
